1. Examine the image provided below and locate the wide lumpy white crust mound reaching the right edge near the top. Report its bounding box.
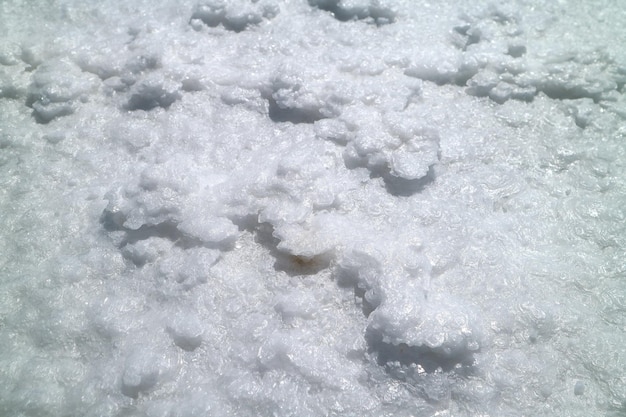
[405,5,624,104]
